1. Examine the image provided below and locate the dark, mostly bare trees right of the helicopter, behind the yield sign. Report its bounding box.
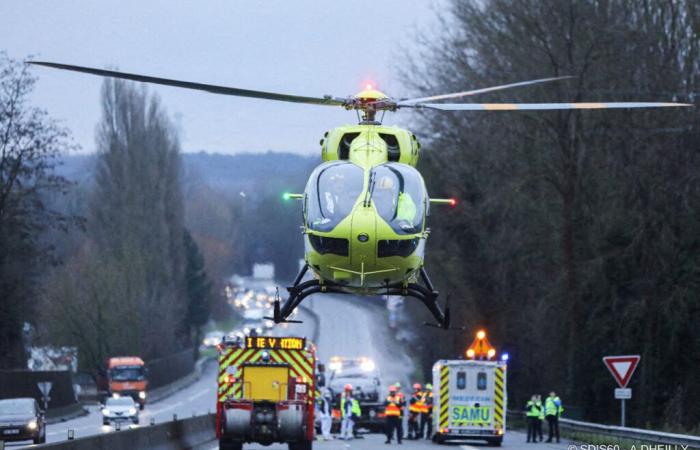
[405,0,700,431]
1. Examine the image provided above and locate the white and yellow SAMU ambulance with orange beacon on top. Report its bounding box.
[432,330,508,446]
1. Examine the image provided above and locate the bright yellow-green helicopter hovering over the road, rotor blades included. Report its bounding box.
[27,61,691,329]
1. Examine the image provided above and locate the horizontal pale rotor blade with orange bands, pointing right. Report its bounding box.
[404,102,693,111]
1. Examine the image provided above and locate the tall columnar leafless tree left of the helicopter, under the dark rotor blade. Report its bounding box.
[44,80,192,368]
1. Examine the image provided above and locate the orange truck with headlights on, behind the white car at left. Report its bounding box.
[97,356,148,409]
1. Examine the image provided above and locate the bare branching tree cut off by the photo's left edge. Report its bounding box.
[0,52,75,368]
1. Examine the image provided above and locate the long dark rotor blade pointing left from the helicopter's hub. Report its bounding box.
[27,61,346,106]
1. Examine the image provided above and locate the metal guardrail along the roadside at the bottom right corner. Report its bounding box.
[508,411,700,450]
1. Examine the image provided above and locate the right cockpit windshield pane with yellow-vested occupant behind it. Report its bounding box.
[370,163,427,234]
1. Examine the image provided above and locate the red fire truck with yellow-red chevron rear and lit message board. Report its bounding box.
[216,336,316,450]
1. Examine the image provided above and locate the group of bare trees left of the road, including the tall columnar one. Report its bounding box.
[0,51,213,370]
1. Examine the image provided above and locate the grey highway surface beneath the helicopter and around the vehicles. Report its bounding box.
[15,295,567,450]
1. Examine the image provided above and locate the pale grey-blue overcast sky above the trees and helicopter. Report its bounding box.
[0,0,449,155]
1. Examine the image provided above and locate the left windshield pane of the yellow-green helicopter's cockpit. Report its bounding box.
[306,162,364,231]
